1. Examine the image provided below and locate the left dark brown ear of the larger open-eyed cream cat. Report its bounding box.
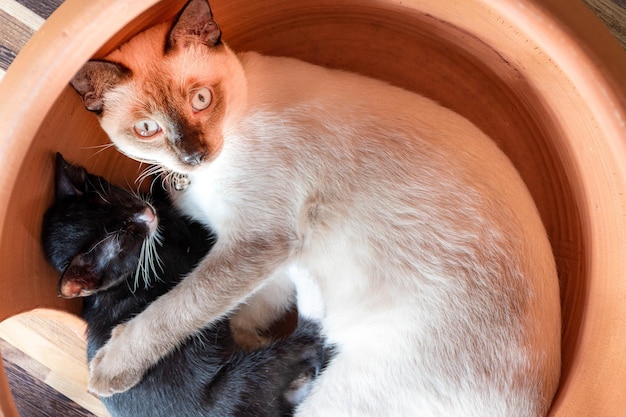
[70,60,130,114]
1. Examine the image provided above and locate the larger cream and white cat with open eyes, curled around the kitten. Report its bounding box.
[70,0,561,417]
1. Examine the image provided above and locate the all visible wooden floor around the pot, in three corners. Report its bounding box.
[0,0,626,417]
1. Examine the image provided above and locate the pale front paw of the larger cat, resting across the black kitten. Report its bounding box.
[88,325,146,397]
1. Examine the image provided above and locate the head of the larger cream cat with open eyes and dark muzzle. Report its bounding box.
[71,0,245,173]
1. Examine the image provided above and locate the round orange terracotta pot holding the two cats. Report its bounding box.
[0,0,626,417]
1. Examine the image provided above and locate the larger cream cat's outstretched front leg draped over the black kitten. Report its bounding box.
[89,232,294,396]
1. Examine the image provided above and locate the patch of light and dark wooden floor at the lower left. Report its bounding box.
[0,310,108,417]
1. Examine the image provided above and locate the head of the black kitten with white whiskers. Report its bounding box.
[42,155,158,298]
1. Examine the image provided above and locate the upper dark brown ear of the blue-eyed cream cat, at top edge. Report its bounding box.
[165,0,222,53]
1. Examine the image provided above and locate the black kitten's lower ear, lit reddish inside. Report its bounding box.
[57,254,102,298]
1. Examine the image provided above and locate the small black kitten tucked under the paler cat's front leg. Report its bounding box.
[42,154,330,417]
